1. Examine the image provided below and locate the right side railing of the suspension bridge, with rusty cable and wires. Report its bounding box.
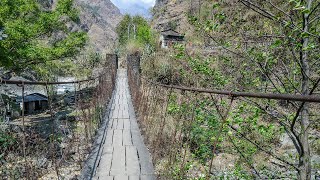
[127,54,320,179]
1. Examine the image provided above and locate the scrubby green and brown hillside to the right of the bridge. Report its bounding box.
[124,0,320,179]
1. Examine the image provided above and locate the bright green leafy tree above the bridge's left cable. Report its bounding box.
[0,0,87,72]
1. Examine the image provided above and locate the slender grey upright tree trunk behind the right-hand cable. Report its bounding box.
[298,0,313,180]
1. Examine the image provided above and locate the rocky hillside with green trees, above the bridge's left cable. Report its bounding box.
[0,0,122,78]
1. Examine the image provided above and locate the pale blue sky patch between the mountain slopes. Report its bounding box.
[111,0,155,17]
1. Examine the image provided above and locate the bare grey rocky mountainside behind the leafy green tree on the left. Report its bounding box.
[0,0,122,80]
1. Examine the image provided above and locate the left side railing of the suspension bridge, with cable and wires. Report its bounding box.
[0,55,117,179]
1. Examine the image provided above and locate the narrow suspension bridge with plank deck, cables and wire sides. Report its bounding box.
[0,55,320,180]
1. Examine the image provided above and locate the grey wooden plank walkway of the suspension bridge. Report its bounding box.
[94,69,156,180]
